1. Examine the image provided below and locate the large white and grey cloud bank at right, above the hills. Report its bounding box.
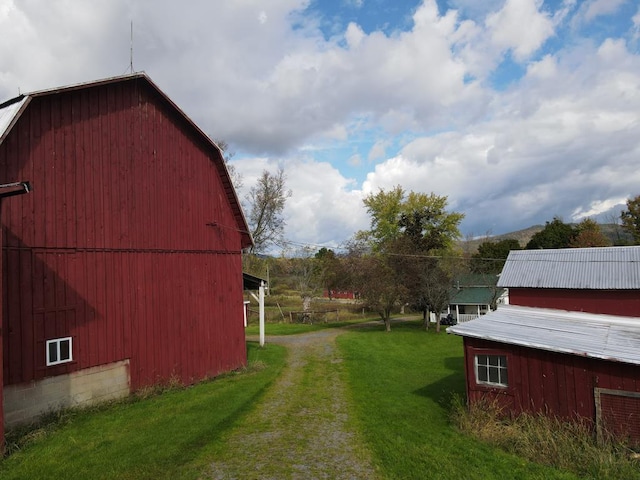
[366,35,640,233]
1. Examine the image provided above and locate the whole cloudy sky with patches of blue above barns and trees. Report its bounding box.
[0,0,640,253]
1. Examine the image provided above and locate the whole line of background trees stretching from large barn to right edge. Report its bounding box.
[222,142,640,331]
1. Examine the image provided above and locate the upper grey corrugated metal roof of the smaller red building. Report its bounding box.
[498,246,640,290]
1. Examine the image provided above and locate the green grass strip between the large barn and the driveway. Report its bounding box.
[0,344,286,480]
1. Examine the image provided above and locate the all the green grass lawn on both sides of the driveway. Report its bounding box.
[0,321,596,480]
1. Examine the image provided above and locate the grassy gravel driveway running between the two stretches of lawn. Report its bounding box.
[205,329,379,480]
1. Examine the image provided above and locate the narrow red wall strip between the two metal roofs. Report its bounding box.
[509,288,640,317]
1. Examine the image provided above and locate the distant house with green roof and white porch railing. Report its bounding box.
[442,274,508,323]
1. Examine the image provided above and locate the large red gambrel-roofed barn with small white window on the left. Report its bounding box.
[0,74,252,444]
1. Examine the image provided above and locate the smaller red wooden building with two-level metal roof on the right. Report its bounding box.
[447,247,640,443]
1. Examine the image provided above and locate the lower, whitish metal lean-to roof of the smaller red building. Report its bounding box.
[447,305,640,365]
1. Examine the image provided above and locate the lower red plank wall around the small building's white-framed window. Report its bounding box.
[464,337,640,428]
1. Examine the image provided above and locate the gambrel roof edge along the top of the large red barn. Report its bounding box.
[0,72,253,248]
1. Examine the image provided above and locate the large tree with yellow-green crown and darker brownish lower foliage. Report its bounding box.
[354,186,463,329]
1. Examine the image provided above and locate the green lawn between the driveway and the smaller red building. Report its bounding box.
[338,322,576,480]
